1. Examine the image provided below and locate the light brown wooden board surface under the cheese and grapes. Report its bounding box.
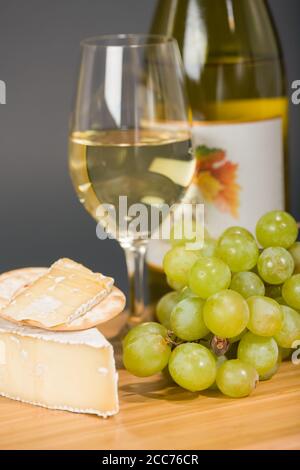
[0,363,300,450]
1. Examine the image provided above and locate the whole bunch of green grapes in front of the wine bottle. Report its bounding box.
[123,211,300,398]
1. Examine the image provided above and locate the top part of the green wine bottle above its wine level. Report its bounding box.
[152,0,281,61]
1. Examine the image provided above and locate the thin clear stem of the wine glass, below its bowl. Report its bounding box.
[122,240,148,325]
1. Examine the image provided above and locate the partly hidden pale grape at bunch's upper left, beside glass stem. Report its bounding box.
[163,246,199,287]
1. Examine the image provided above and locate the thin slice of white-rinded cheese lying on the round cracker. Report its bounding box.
[1,259,114,328]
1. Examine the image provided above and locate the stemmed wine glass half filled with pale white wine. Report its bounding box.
[69,34,195,330]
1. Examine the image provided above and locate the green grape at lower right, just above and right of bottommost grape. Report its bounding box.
[238,331,279,376]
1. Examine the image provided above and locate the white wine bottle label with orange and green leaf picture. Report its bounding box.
[193,118,284,237]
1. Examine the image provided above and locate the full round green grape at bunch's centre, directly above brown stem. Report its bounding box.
[203,290,249,338]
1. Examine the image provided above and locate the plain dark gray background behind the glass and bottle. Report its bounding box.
[0,0,300,294]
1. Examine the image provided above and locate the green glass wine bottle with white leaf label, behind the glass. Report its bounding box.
[148,0,288,298]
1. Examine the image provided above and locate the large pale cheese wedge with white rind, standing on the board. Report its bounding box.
[0,319,119,417]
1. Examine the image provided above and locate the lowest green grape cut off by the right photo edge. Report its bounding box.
[274,305,300,348]
